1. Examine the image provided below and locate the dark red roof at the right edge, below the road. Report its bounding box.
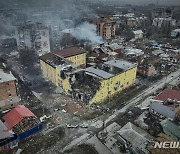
[154,88,180,101]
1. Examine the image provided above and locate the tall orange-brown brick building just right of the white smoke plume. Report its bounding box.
[91,17,116,40]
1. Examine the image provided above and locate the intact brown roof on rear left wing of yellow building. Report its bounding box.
[53,47,85,58]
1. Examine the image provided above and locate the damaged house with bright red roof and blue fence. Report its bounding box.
[3,105,42,140]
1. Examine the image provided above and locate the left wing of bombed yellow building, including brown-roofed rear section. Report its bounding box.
[40,47,86,93]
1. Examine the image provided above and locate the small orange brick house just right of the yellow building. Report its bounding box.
[138,65,156,77]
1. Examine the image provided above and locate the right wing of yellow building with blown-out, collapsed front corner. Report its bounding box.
[70,60,137,104]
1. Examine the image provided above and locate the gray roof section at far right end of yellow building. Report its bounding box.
[105,60,137,70]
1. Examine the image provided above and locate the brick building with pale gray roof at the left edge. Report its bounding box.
[0,62,20,110]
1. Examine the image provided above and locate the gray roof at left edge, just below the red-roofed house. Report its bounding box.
[0,120,14,139]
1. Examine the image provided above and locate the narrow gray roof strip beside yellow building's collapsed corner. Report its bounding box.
[85,67,114,79]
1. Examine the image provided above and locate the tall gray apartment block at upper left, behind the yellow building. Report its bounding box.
[15,24,50,55]
